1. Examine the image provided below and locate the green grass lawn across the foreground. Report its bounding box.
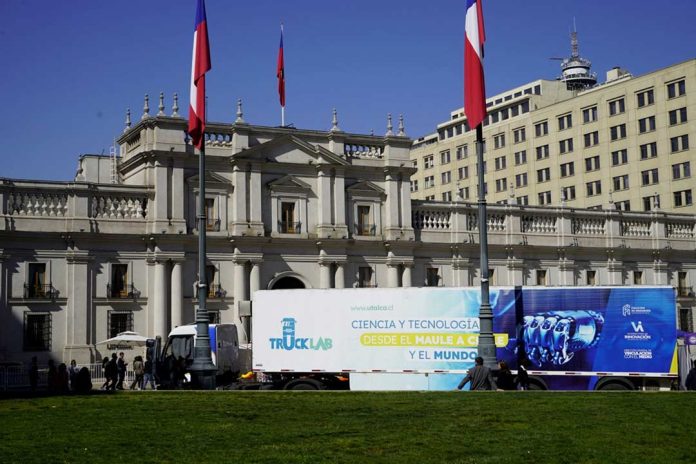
[0,391,696,463]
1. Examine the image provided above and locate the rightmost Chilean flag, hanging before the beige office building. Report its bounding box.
[464,0,486,129]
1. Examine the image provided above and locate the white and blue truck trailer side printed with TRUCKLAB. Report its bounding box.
[253,287,676,390]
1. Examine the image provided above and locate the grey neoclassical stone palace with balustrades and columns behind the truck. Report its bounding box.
[0,99,696,363]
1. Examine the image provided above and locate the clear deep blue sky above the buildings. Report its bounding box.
[0,0,696,180]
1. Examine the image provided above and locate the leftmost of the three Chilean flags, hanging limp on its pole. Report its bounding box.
[188,0,210,149]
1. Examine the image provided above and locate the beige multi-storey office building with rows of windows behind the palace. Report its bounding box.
[411,56,696,214]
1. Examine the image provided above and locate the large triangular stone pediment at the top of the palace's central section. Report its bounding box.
[231,134,350,166]
